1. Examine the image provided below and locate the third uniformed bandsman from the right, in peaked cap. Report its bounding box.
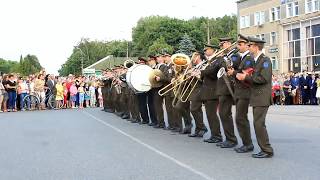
[217,38,238,148]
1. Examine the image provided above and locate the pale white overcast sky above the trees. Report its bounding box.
[0,0,236,73]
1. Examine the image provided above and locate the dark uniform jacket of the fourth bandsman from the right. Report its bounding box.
[201,59,219,100]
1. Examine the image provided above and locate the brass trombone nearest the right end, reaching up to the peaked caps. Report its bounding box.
[180,42,237,102]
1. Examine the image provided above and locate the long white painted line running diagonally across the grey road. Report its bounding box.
[82,111,214,180]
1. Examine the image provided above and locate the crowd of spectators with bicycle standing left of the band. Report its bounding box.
[0,70,103,112]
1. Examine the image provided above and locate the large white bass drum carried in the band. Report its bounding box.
[126,64,153,93]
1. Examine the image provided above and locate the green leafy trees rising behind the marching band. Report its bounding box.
[59,15,237,75]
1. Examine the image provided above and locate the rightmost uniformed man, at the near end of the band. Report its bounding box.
[236,37,273,158]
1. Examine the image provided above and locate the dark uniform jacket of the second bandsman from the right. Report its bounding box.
[233,53,254,99]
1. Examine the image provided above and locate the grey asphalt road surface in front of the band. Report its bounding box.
[0,106,320,180]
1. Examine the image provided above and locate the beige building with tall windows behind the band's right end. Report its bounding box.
[237,0,320,73]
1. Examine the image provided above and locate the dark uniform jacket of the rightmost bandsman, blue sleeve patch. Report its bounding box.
[245,54,272,107]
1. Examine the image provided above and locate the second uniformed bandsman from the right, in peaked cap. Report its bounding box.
[228,34,254,153]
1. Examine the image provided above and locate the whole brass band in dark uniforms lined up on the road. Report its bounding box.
[102,35,274,158]
